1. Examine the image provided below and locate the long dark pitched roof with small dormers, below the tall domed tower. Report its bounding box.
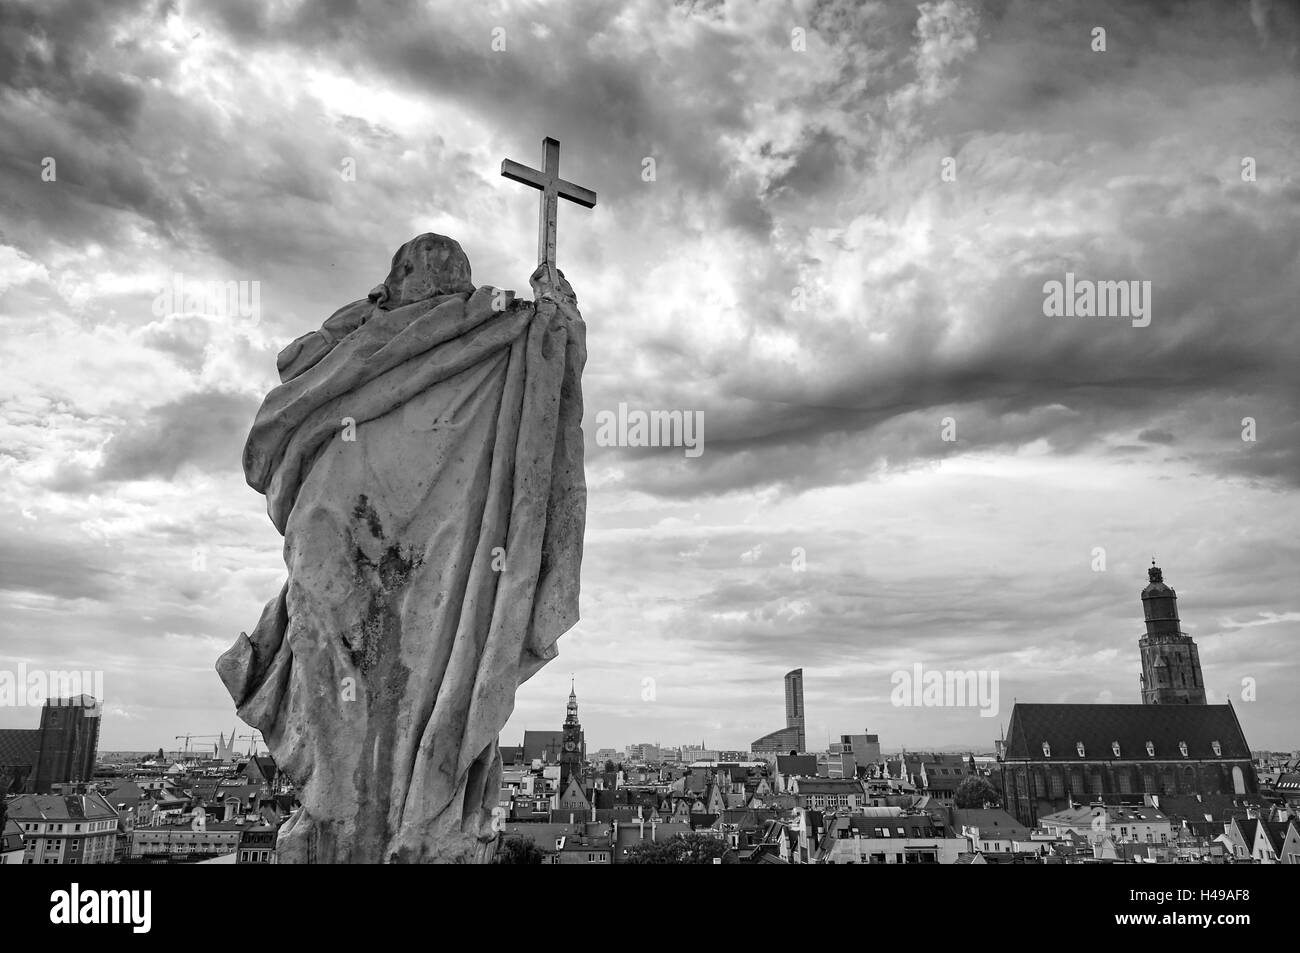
[1006,702,1251,762]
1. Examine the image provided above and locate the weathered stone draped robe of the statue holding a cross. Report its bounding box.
[217,287,586,863]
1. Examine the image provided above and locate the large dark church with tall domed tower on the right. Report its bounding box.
[998,566,1258,826]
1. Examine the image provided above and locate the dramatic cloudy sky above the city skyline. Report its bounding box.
[0,0,1300,749]
